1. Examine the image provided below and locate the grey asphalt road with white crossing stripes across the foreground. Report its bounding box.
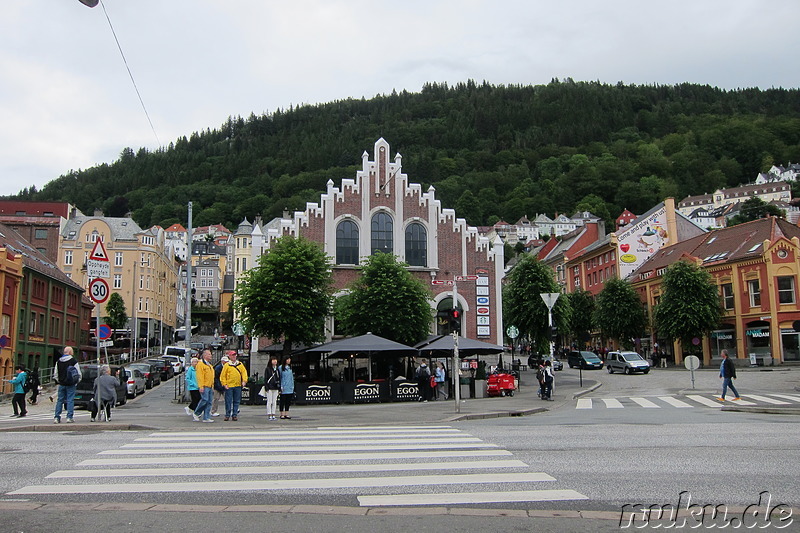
[0,369,800,531]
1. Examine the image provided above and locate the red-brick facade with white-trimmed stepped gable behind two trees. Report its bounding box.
[247,138,504,344]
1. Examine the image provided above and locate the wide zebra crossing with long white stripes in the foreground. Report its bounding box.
[8,426,588,507]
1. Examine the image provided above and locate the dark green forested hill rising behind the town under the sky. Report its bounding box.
[10,79,800,228]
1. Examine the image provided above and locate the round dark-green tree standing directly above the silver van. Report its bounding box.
[594,278,647,349]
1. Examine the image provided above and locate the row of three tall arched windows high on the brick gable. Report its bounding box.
[336,212,428,267]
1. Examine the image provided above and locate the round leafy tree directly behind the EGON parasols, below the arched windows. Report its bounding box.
[335,253,433,345]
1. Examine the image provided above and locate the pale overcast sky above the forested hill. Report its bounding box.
[0,0,800,195]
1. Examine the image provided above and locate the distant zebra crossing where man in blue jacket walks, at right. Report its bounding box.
[575,393,800,409]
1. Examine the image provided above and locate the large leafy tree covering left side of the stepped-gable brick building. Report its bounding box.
[234,236,332,355]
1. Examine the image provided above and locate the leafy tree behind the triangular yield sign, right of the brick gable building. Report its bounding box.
[503,254,571,353]
